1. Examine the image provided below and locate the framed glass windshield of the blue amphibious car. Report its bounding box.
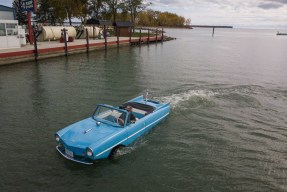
[93,105,126,126]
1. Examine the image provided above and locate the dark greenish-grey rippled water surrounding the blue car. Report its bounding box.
[0,29,287,192]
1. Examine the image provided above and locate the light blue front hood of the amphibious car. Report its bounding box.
[57,118,121,148]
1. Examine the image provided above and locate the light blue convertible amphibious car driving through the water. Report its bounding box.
[55,96,170,164]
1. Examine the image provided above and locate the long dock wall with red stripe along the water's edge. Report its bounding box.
[0,35,164,65]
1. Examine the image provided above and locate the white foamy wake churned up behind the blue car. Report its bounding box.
[155,90,217,108]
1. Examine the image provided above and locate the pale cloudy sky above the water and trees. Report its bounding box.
[0,0,287,28]
